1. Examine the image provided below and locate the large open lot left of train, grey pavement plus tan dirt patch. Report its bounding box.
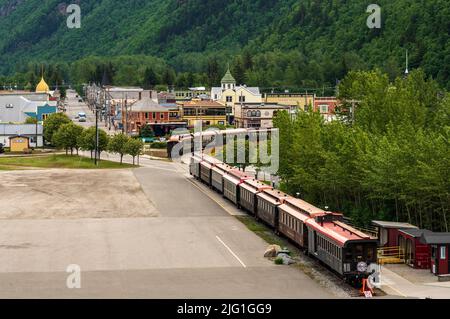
[0,162,333,298]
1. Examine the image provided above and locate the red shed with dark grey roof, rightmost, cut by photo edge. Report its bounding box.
[420,232,450,275]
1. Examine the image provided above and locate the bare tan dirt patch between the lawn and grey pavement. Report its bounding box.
[0,169,158,219]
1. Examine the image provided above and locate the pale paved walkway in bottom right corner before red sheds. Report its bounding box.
[381,266,450,299]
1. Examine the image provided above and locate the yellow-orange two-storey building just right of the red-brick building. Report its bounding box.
[178,99,227,127]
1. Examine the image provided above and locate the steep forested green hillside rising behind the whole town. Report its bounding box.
[0,0,450,88]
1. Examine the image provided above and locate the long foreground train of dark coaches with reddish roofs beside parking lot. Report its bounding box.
[189,154,378,286]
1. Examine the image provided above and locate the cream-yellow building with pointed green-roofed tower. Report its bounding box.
[211,70,262,114]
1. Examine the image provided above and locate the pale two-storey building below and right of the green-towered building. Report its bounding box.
[234,103,291,129]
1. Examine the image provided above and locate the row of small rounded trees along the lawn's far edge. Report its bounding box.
[44,113,143,165]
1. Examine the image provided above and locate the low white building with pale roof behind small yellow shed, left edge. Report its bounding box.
[0,124,44,148]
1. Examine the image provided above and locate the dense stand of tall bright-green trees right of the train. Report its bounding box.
[275,70,450,231]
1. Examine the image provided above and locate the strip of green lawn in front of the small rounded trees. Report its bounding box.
[0,154,137,170]
